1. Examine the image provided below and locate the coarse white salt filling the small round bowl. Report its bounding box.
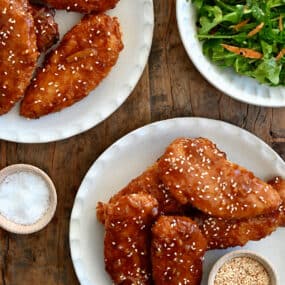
[0,171,50,225]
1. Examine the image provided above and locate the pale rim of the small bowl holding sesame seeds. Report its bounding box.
[208,250,279,285]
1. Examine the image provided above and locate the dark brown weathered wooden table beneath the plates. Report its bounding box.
[0,0,285,285]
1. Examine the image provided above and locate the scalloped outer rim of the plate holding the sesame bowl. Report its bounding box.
[69,117,285,285]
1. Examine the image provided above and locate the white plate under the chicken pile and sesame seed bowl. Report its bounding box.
[70,118,285,285]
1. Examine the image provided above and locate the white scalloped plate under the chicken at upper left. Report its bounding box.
[0,0,154,143]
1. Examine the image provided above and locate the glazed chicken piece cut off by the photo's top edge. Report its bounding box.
[39,0,119,14]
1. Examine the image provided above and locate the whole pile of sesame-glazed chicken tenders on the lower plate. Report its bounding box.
[97,138,285,285]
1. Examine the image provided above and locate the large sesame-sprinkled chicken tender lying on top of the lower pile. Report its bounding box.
[158,138,282,219]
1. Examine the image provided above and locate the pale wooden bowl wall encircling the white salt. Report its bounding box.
[0,164,57,234]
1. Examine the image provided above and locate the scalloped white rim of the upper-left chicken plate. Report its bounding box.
[0,0,154,143]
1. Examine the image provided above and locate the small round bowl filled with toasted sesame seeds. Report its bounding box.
[208,250,279,285]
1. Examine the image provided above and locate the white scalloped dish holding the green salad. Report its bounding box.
[176,0,285,107]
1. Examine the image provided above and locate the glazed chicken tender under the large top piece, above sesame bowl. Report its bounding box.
[193,210,282,249]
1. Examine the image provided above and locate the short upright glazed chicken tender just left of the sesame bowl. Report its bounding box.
[151,216,207,285]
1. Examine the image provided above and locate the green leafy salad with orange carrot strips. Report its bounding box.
[192,0,285,86]
